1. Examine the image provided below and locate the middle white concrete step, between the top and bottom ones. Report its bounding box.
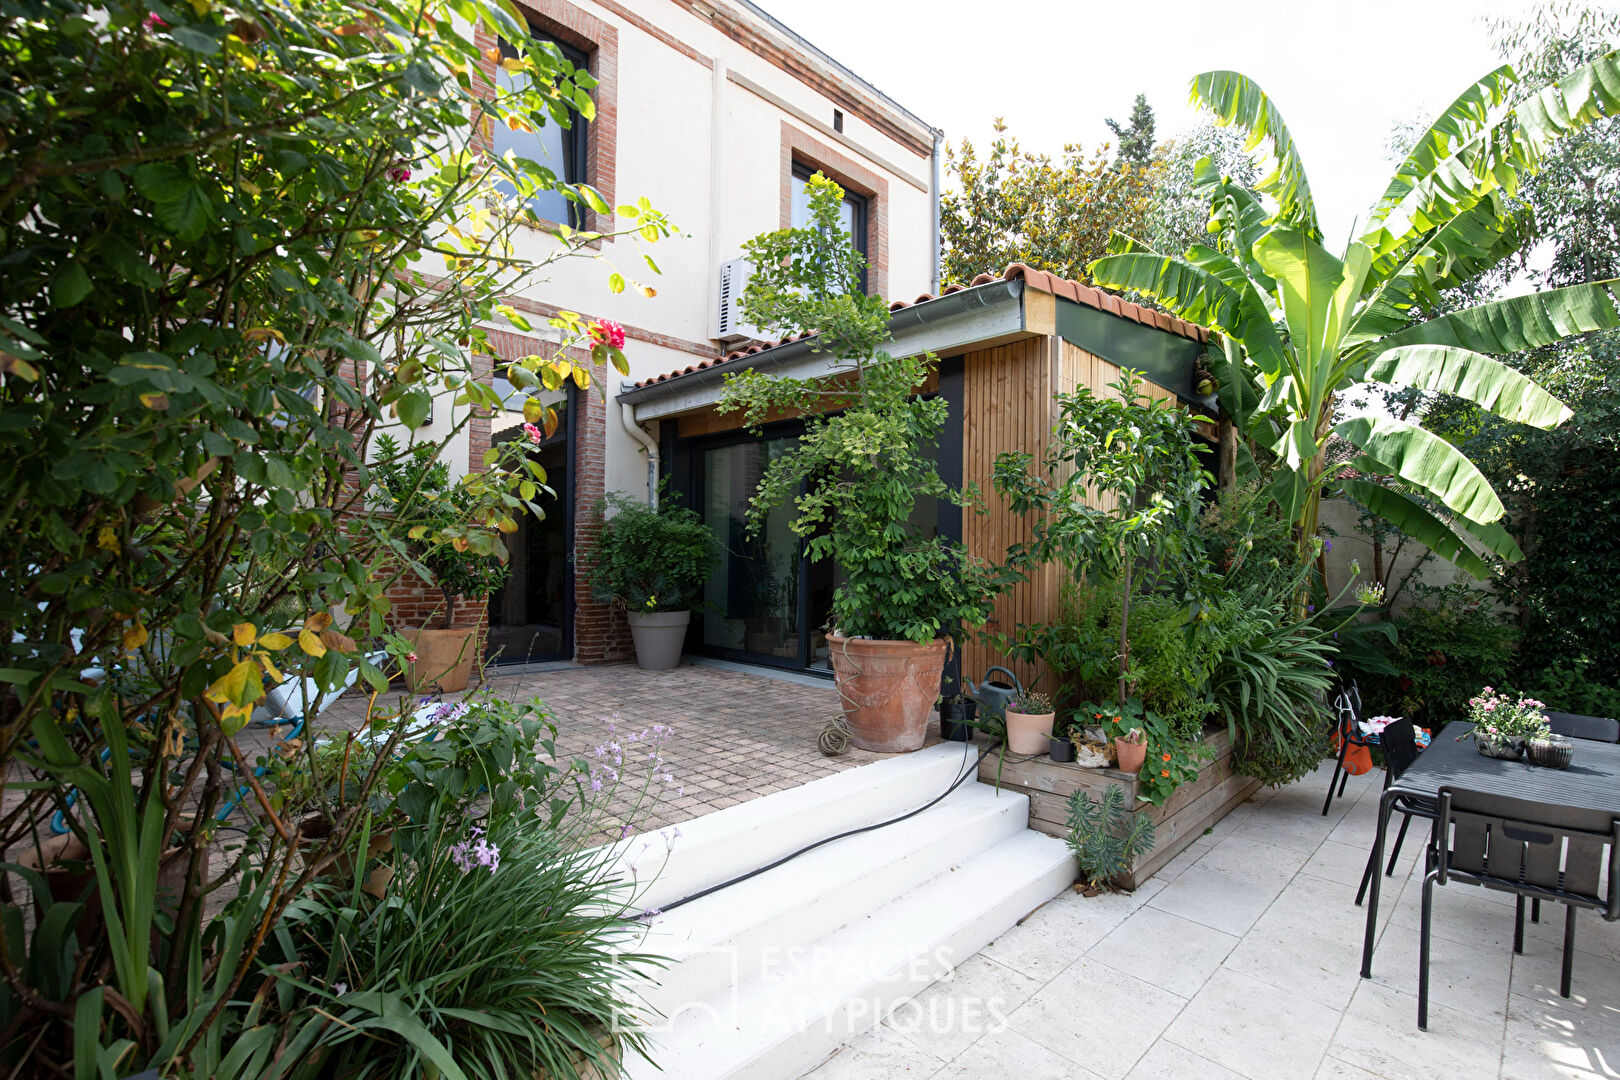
[643,780,1029,1015]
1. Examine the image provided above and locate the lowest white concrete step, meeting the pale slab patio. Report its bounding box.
[627,835,1074,1080]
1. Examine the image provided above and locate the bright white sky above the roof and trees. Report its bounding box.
[758,0,1526,251]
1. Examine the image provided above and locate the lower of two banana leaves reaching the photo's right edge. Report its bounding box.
[1380,280,1620,353]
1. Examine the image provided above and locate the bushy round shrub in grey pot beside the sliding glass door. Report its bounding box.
[590,492,716,670]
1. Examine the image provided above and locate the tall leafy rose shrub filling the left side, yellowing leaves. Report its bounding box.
[0,0,669,1077]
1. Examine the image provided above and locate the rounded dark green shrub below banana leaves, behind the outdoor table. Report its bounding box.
[1362,583,1518,730]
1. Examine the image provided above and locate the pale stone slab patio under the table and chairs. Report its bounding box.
[805,769,1620,1080]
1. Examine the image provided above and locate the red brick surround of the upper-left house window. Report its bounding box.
[473,0,619,233]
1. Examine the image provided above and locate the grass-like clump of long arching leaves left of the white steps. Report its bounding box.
[266,818,653,1080]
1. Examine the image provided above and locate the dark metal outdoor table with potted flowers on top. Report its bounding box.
[1361,721,1620,978]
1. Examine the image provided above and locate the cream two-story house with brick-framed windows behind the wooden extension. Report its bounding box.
[395,0,943,662]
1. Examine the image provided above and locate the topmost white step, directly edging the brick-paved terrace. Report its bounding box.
[612,743,977,910]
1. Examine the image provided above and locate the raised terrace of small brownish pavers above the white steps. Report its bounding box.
[311,664,861,831]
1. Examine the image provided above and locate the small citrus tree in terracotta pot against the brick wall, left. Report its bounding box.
[373,434,507,693]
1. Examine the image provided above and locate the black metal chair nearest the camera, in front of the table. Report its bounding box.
[1418,787,1620,1030]
